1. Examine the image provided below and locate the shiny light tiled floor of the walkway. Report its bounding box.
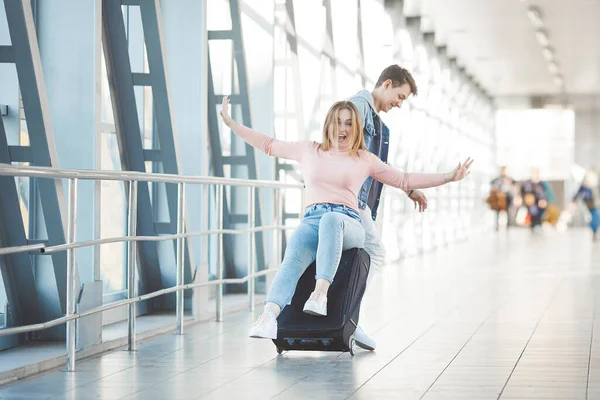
[0,230,600,400]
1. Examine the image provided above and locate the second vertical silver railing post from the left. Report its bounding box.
[127,181,138,351]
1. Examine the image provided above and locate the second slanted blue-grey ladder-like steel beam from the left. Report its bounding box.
[103,0,192,308]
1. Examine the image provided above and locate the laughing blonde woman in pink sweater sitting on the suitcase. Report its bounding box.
[221,97,473,339]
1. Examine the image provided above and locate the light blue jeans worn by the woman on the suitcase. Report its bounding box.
[266,204,365,310]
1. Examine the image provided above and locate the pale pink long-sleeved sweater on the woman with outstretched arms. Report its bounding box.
[234,125,446,211]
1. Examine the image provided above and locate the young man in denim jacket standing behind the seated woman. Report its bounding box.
[349,65,427,350]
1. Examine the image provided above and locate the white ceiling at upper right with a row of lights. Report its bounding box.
[414,0,600,96]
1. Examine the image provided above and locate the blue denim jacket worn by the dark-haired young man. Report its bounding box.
[349,90,390,220]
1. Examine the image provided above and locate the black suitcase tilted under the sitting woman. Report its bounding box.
[273,249,370,355]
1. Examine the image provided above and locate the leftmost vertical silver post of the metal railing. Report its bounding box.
[66,178,78,372]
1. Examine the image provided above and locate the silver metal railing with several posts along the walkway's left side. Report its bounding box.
[0,164,304,371]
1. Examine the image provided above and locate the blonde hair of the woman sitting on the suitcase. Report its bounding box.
[320,101,367,156]
